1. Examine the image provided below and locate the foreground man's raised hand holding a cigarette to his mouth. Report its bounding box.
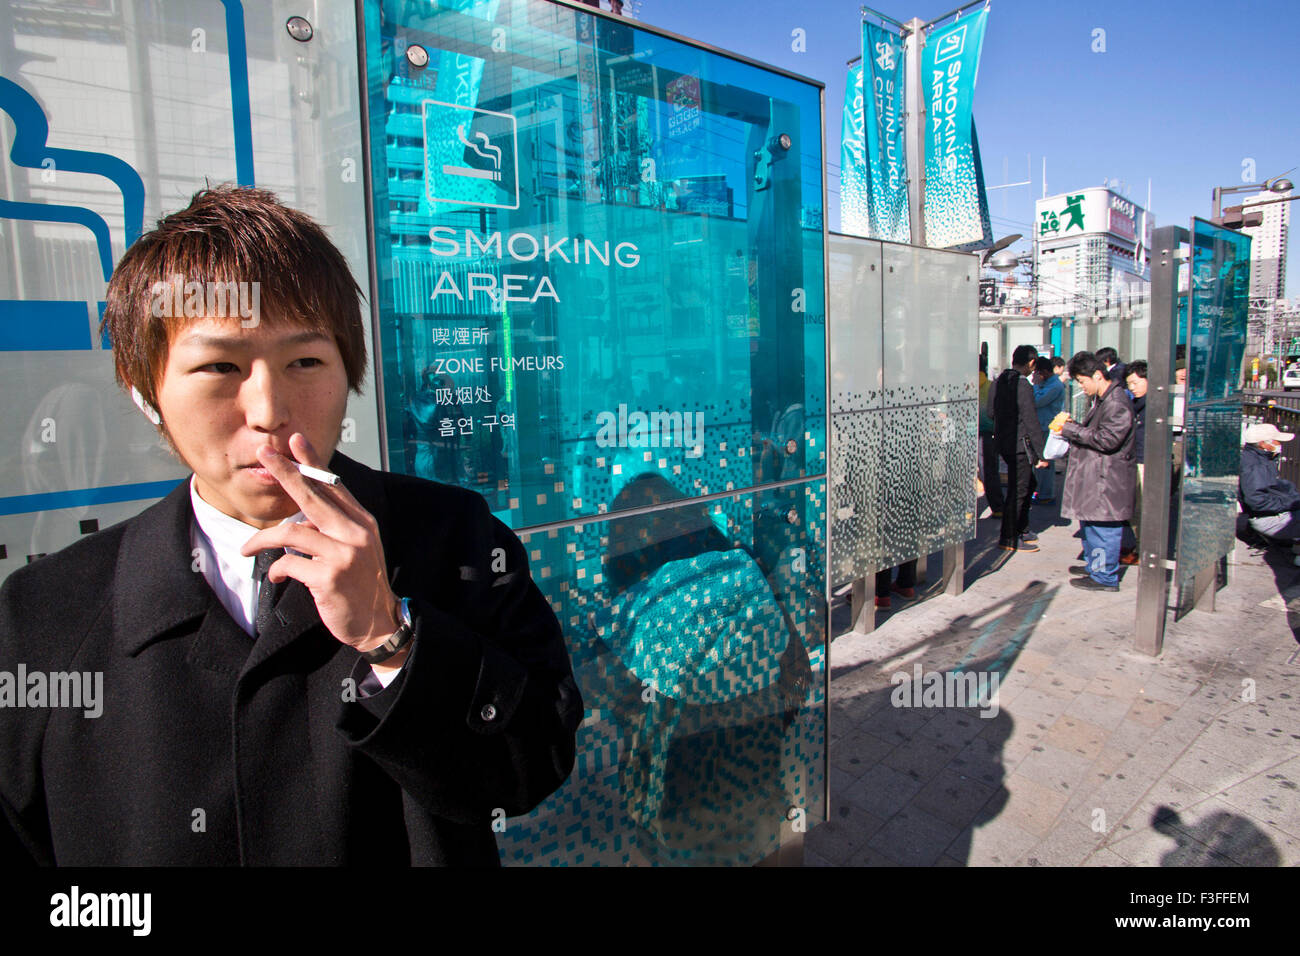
[239,432,398,665]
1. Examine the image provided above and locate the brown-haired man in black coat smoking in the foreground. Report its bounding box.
[0,187,582,866]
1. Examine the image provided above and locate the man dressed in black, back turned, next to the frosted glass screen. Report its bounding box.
[988,345,1043,551]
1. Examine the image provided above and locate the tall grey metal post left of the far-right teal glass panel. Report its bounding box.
[1134,226,1187,657]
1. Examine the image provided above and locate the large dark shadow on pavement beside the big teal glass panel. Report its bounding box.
[806,581,1057,866]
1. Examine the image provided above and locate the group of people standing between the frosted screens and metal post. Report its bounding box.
[980,345,1147,592]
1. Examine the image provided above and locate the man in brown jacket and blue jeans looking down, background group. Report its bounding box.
[1056,352,1138,591]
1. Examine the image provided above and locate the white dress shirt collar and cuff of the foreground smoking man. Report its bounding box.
[190,476,402,696]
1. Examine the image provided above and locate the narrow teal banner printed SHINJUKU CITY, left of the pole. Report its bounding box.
[862,23,911,242]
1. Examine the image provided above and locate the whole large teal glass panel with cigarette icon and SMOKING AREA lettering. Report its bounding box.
[365,0,828,865]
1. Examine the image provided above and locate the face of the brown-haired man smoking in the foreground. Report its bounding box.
[157,319,347,528]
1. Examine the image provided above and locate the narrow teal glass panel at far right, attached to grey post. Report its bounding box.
[1178,219,1251,614]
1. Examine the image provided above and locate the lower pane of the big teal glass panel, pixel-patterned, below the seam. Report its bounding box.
[498,473,827,866]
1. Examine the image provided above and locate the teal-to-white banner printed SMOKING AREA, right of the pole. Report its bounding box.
[920,8,992,248]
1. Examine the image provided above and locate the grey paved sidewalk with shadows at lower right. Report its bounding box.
[805,499,1300,866]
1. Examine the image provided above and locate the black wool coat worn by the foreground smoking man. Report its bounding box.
[0,453,582,866]
